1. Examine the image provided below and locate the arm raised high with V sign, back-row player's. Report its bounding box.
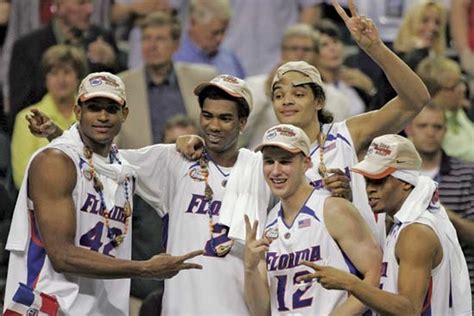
[333,0,430,155]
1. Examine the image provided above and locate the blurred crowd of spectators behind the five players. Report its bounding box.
[0,0,474,310]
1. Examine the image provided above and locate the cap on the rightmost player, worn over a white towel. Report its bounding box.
[352,134,421,179]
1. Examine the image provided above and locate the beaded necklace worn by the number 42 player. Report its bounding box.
[84,145,132,248]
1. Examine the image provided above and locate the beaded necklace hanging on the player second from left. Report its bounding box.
[199,147,234,257]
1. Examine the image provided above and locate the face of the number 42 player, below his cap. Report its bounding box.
[74,98,128,153]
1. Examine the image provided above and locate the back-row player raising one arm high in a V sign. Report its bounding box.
[177,1,430,244]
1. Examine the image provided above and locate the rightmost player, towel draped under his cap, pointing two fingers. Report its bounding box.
[302,135,472,316]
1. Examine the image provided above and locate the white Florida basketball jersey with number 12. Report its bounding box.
[265,190,357,315]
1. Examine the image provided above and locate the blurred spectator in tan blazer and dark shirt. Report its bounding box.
[117,12,217,149]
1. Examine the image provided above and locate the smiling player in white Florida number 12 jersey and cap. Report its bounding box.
[245,124,382,315]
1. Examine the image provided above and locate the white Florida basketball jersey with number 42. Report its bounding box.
[5,146,133,316]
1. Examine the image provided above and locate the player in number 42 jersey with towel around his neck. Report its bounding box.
[5,72,202,315]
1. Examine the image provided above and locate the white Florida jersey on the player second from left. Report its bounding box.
[122,145,252,316]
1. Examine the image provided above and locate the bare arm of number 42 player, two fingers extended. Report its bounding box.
[28,149,202,279]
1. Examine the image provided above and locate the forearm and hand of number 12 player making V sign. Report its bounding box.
[244,215,270,316]
